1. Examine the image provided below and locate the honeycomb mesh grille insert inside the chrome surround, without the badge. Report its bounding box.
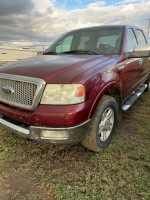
[0,78,37,106]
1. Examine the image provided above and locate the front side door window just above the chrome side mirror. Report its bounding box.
[126,29,137,52]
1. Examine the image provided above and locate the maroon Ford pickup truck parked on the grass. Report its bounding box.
[0,25,150,151]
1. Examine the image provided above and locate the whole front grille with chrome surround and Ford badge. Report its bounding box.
[0,73,46,110]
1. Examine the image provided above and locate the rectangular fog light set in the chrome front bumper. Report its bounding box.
[41,130,69,140]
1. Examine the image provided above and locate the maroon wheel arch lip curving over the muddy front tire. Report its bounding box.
[88,81,121,119]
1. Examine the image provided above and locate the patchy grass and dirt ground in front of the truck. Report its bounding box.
[0,93,150,200]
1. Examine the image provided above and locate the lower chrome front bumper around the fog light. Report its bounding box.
[0,116,90,145]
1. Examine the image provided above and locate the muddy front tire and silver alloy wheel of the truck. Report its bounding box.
[82,95,118,152]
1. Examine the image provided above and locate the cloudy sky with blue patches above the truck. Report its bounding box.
[0,0,150,46]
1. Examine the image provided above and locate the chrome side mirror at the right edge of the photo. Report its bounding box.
[126,44,150,58]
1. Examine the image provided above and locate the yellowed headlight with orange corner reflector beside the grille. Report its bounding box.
[41,84,85,105]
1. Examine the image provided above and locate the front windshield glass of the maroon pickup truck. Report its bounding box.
[45,27,123,55]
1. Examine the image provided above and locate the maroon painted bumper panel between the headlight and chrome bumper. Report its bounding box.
[0,101,93,127]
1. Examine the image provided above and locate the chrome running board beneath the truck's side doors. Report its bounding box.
[122,84,147,111]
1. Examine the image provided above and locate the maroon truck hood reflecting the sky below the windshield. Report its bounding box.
[0,55,112,83]
